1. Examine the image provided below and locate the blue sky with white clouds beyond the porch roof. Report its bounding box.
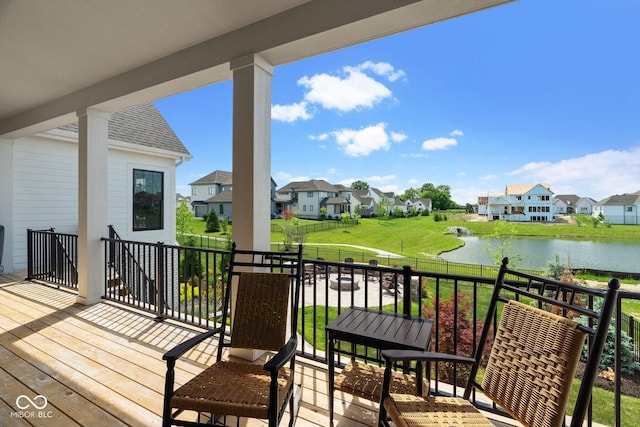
[156,0,640,204]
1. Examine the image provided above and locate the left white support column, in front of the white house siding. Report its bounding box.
[77,109,109,305]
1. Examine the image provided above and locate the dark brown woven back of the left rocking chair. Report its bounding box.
[231,272,291,351]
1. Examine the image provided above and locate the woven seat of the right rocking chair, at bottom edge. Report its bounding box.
[383,394,494,427]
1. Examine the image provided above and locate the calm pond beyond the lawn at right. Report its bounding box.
[440,236,640,273]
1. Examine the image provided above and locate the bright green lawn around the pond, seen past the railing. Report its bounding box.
[186,215,640,425]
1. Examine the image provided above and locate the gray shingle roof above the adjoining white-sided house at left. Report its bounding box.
[60,104,191,157]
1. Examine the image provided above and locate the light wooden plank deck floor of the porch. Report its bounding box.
[0,275,377,427]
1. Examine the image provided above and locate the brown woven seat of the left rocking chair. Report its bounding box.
[171,361,293,419]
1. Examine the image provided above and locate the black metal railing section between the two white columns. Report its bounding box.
[102,234,229,328]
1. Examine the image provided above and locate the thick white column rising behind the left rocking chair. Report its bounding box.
[231,55,273,250]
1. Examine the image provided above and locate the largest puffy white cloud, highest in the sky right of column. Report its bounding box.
[298,67,391,112]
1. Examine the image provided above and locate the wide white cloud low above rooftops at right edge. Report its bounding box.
[505,146,640,200]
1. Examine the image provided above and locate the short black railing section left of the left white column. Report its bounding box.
[27,228,78,289]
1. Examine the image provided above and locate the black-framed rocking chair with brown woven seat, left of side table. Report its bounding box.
[163,243,302,427]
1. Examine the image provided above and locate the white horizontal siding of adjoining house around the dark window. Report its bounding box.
[5,134,176,272]
